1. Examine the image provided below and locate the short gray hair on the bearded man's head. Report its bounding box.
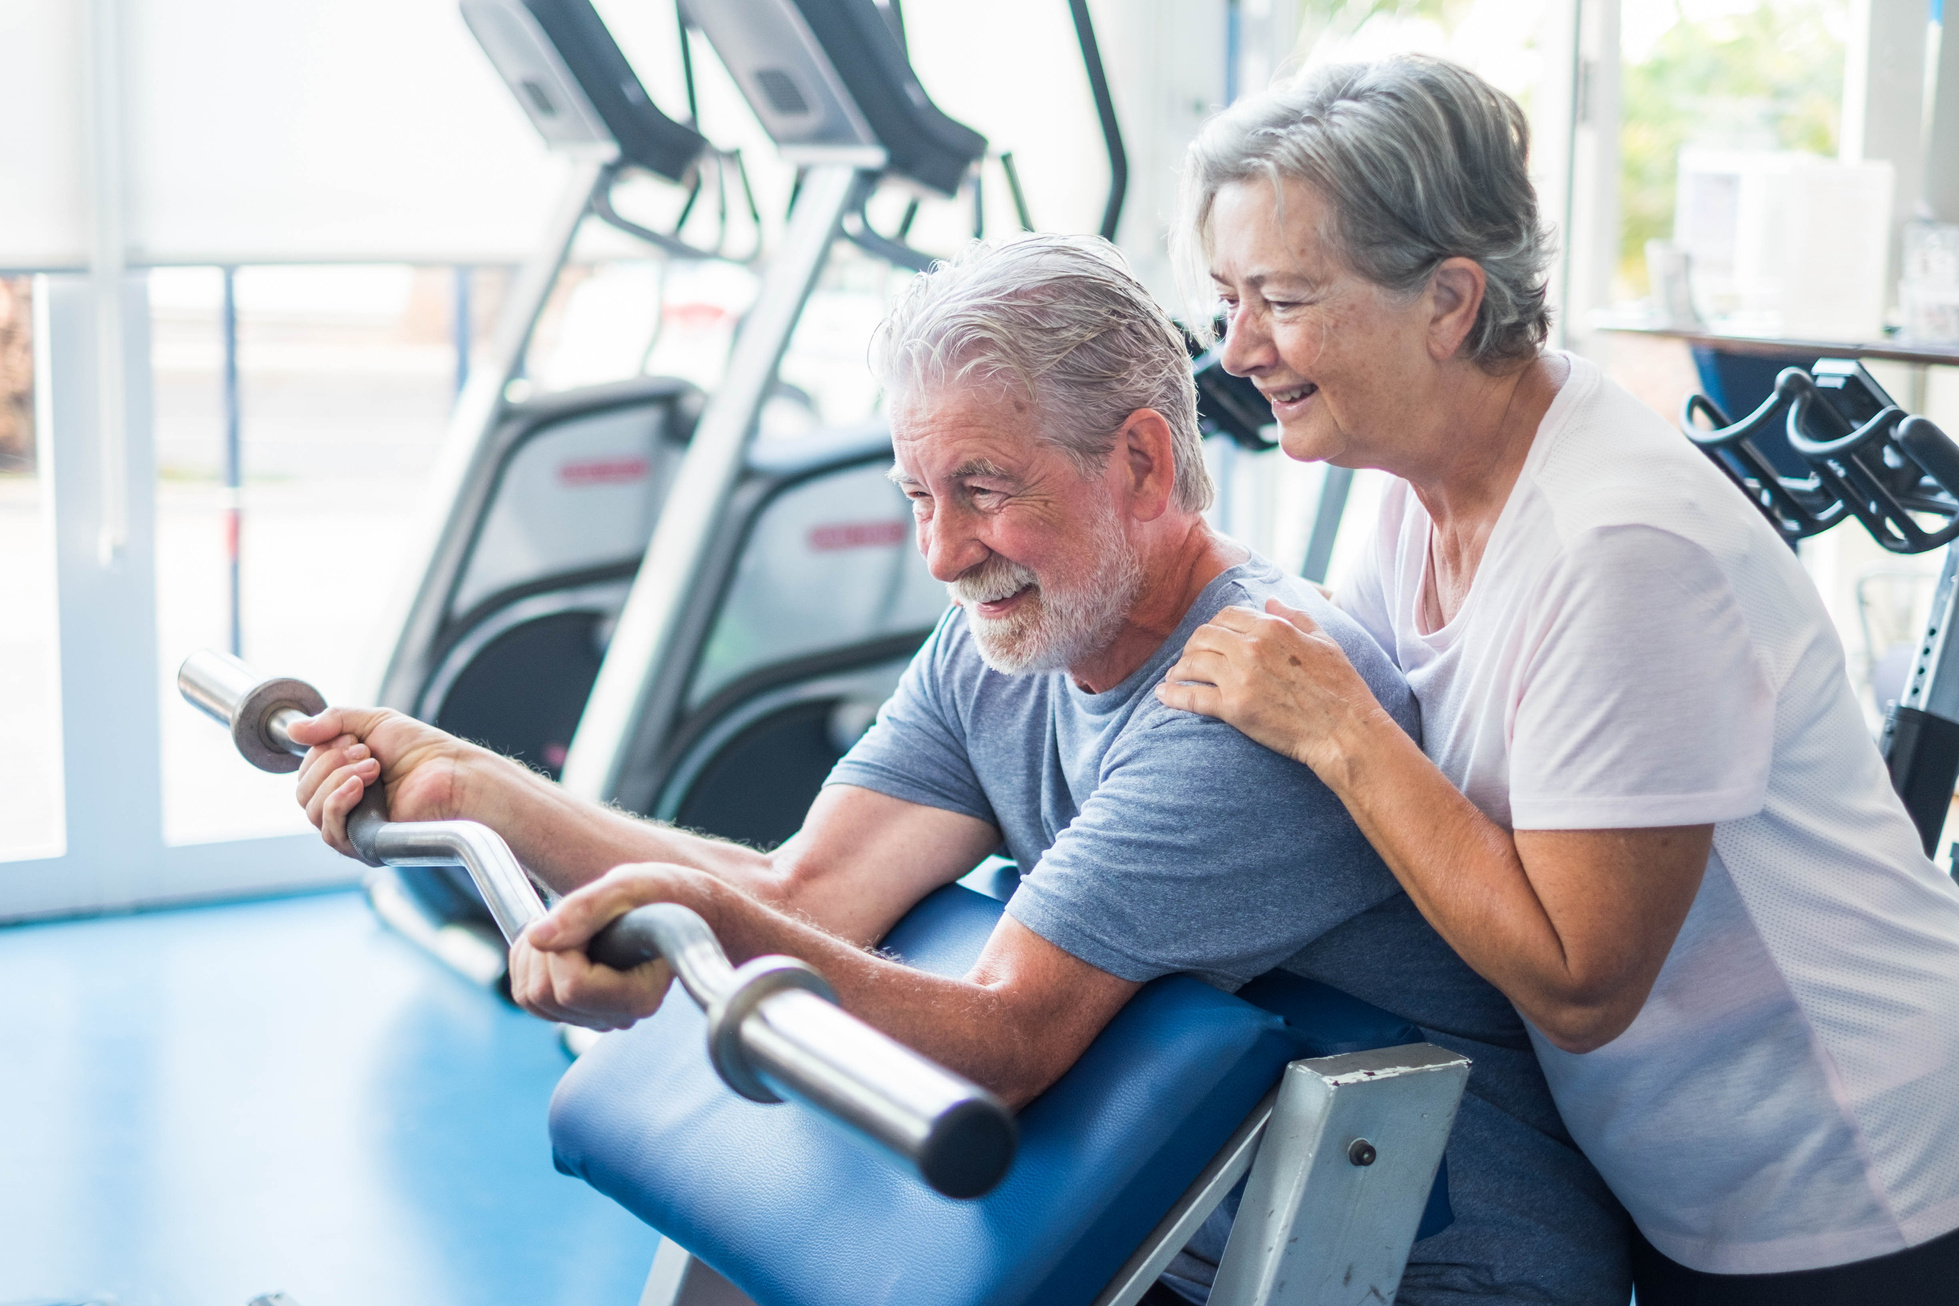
[870,235,1213,513]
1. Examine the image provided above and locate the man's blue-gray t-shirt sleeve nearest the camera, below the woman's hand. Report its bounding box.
[1007,707,1395,989]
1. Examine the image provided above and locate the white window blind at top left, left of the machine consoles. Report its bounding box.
[0,0,560,268]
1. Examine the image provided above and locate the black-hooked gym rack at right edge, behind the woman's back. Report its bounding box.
[1681,358,1959,856]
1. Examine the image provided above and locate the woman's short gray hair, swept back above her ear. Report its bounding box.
[1171,55,1552,370]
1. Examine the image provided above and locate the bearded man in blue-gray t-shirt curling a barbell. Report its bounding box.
[294,237,1628,1306]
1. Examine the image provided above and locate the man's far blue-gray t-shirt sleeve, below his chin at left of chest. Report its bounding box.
[823,609,999,824]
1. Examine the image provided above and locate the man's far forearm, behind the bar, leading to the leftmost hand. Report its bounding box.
[456,752,774,899]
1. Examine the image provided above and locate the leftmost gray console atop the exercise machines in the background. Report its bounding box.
[462,0,707,182]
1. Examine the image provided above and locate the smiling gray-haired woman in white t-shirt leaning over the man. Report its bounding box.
[1158,59,1959,1306]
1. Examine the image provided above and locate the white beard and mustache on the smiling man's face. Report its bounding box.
[946,509,1142,676]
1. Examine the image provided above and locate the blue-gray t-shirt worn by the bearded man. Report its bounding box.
[829,558,1630,1306]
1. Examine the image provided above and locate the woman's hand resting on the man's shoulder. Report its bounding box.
[1156,599,1399,791]
